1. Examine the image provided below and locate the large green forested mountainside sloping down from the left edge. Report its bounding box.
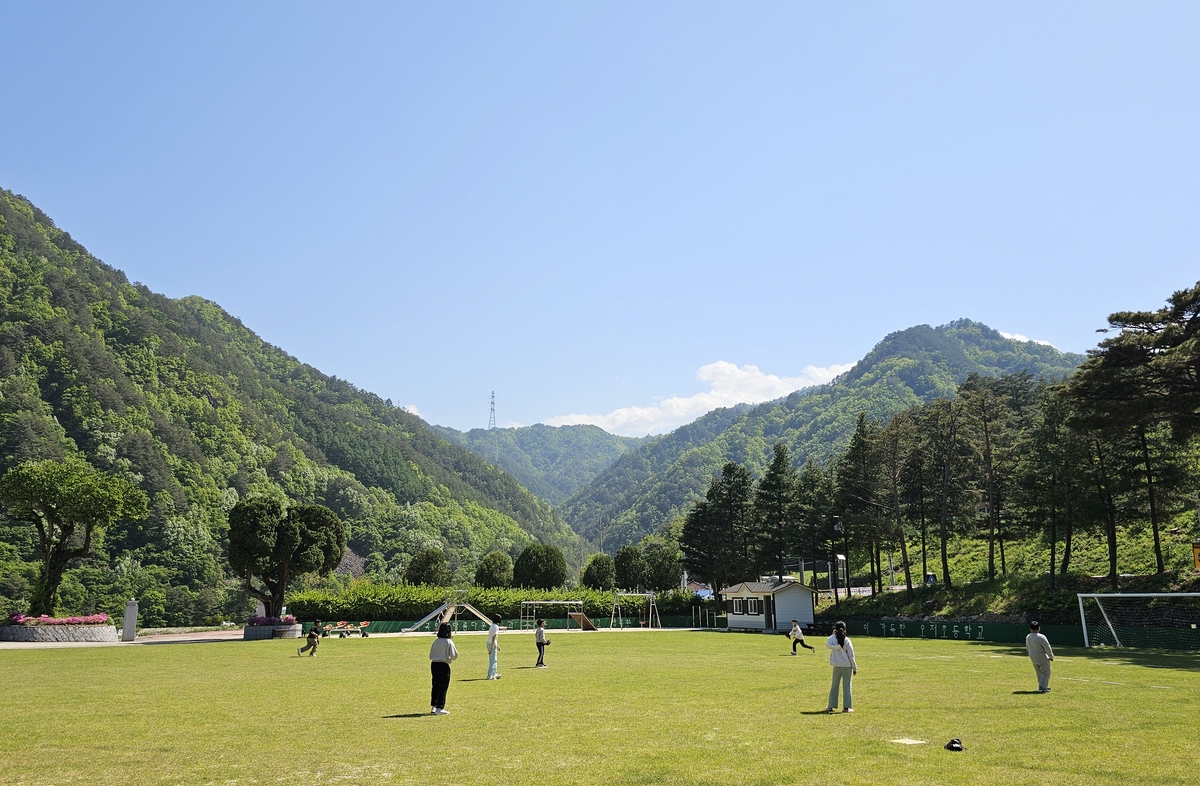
[0,191,581,625]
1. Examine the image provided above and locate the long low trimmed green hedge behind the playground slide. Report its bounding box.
[287,580,712,622]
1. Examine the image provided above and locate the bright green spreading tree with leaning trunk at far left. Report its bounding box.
[0,457,148,617]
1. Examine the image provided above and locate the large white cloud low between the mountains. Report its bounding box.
[546,360,853,437]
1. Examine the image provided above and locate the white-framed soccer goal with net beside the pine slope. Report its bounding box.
[1079,593,1200,649]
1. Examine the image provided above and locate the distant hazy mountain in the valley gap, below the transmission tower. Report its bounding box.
[433,424,643,505]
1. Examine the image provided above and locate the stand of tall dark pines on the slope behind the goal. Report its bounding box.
[678,284,1200,617]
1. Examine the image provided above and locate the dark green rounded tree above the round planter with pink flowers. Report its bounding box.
[229,497,346,617]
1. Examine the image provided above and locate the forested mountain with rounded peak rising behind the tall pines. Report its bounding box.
[559,319,1084,551]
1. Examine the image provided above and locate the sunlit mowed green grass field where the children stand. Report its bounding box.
[0,631,1200,786]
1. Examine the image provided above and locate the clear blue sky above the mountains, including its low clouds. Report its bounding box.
[0,2,1200,433]
